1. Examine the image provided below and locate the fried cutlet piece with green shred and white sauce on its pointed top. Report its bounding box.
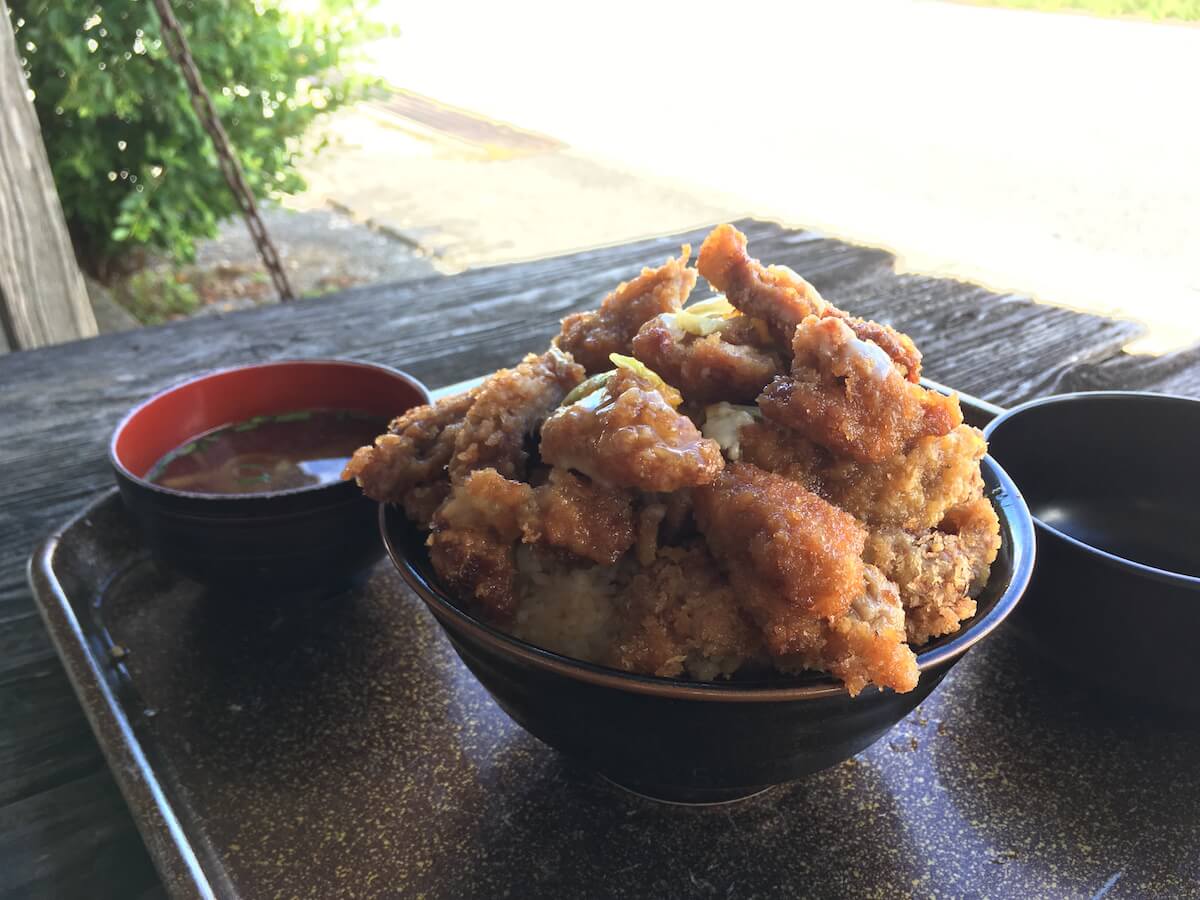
[541,368,724,491]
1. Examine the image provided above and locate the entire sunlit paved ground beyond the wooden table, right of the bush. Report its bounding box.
[114,0,1200,350]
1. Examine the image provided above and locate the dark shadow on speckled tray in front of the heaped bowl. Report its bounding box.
[428,734,920,898]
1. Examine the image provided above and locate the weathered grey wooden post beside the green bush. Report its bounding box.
[0,0,96,352]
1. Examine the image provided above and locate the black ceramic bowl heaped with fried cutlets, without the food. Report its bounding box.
[379,458,1033,803]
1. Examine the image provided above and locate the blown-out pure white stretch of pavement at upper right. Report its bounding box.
[321,0,1200,350]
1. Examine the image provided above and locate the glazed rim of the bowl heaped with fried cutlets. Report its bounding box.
[379,456,1037,703]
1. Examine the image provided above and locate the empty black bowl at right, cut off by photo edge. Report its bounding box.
[986,391,1200,708]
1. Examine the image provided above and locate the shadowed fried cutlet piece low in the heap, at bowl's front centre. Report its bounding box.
[605,544,762,680]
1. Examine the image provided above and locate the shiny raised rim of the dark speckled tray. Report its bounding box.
[26,376,1004,900]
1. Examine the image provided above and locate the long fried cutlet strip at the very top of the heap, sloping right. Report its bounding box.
[696,224,920,381]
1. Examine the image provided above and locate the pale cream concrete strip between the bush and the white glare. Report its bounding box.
[288,103,739,271]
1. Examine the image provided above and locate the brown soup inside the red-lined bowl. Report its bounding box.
[146,409,388,494]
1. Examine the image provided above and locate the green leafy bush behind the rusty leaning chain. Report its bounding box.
[10,0,380,277]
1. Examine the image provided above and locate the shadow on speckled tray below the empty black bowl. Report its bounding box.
[934,634,1200,896]
